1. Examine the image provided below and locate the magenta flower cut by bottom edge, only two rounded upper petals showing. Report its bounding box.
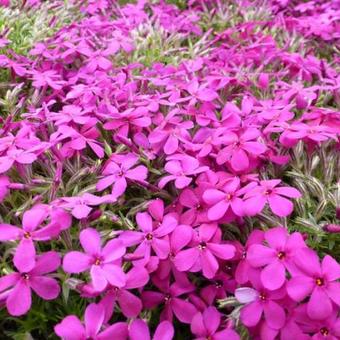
[129,319,175,340]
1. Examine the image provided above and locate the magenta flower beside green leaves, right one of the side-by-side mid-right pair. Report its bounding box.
[244,179,301,217]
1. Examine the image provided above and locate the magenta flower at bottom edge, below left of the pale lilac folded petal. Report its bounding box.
[191,306,240,340]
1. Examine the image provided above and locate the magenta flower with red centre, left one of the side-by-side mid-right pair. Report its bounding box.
[203,177,244,221]
